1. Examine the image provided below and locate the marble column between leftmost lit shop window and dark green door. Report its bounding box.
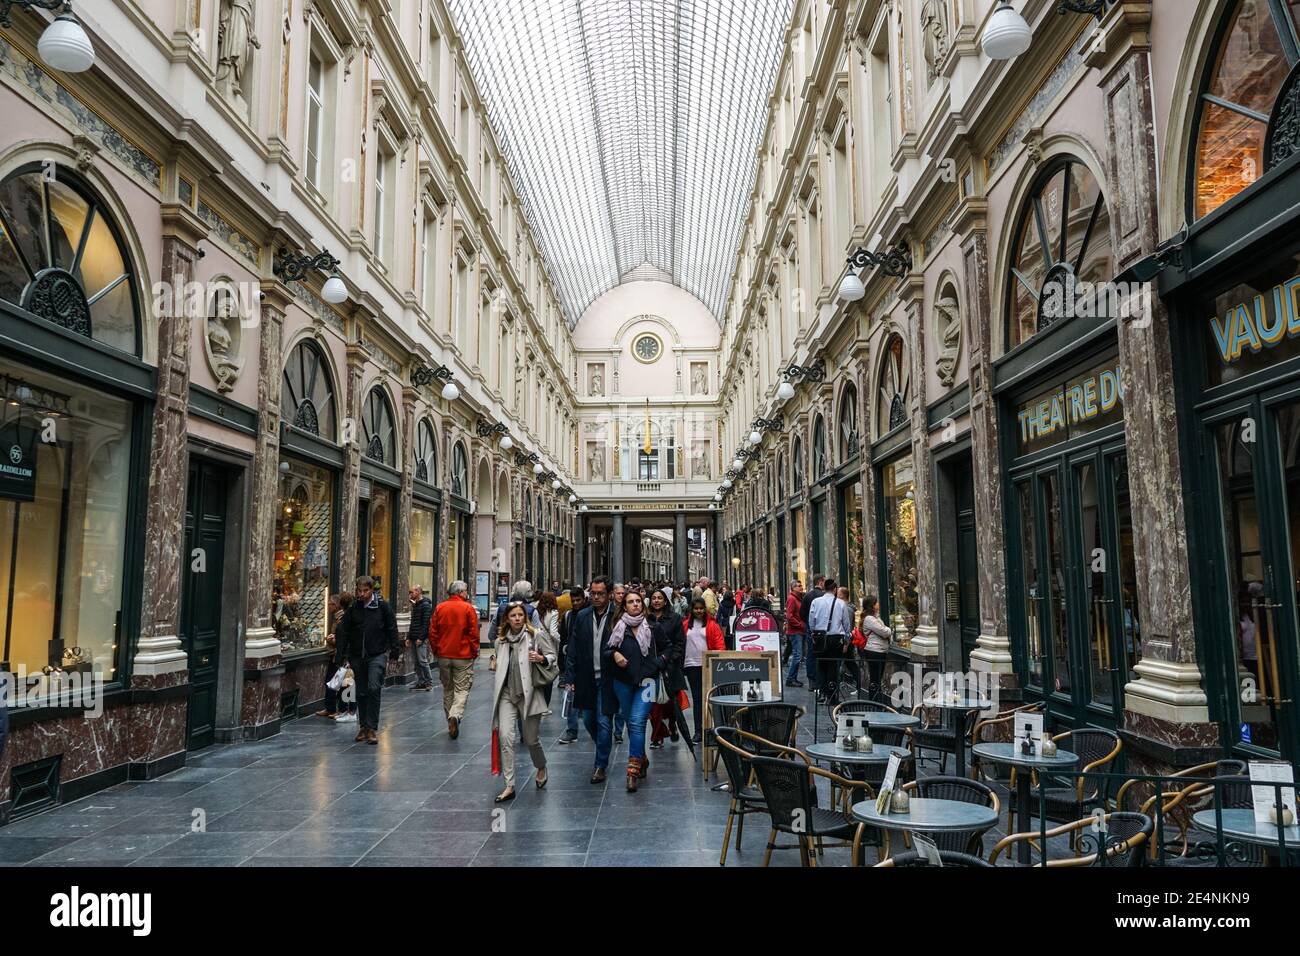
[131,204,208,686]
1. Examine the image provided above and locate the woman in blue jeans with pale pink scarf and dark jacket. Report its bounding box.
[601,591,668,793]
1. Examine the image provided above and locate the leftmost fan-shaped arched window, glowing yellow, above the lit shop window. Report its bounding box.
[0,164,139,355]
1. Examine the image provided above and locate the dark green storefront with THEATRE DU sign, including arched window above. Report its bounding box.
[995,155,1141,728]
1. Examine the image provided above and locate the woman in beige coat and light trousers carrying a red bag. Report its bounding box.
[491,601,559,804]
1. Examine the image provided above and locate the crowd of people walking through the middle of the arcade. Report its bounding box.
[310,574,891,803]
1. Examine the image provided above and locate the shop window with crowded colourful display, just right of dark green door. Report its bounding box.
[270,458,334,654]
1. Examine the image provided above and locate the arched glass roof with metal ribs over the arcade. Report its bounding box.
[451,0,792,324]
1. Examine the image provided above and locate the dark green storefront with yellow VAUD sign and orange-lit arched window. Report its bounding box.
[1160,4,1300,761]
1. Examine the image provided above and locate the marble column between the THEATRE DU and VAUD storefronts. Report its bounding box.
[1088,0,1218,750]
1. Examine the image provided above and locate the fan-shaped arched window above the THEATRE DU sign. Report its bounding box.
[1006,156,1114,351]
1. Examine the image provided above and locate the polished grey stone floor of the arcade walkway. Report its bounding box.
[0,666,1076,866]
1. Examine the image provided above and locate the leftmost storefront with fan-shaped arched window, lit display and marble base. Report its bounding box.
[0,165,150,822]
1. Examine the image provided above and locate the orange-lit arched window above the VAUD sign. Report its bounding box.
[1188,0,1300,219]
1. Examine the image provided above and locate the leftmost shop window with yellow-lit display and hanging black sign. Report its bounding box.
[0,360,133,695]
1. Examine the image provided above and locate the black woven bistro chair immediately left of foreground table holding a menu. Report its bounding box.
[751,757,880,866]
